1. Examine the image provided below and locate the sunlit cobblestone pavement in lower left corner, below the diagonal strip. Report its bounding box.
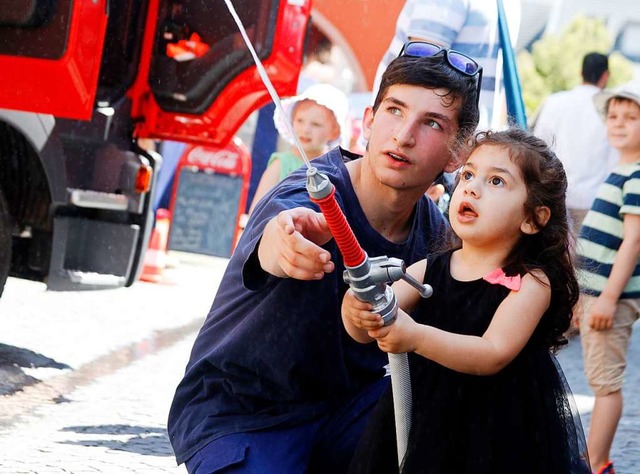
[0,337,193,474]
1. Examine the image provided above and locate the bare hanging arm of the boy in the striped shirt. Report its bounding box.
[587,214,640,331]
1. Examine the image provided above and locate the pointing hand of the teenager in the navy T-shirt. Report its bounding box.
[258,207,334,280]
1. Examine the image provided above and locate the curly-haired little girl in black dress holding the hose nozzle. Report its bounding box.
[342,129,590,474]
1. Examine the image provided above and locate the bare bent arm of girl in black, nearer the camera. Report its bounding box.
[369,274,551,375]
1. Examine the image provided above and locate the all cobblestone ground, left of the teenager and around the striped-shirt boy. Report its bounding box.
[0,252,640,474]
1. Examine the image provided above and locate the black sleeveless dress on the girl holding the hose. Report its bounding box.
[350,252,591,474]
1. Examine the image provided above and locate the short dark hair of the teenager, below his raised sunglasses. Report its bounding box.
[373,55,480,142]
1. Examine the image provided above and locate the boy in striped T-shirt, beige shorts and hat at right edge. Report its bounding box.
[578,82,640,474]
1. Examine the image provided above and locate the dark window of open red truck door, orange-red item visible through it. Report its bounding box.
[149,0,278,114]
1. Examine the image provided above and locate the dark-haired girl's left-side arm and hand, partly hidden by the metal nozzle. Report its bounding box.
[342,260,427,344]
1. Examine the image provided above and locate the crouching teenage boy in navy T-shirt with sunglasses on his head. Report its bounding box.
[168,43,480,474]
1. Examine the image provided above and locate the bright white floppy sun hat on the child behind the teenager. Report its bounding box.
[273,84,349,148]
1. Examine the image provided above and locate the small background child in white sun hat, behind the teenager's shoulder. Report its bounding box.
[249,84,349,214]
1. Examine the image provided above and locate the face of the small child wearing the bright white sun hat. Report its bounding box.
[293,100,340,159]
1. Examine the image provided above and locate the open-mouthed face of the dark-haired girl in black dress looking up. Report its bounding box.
[449,145,537,249]
